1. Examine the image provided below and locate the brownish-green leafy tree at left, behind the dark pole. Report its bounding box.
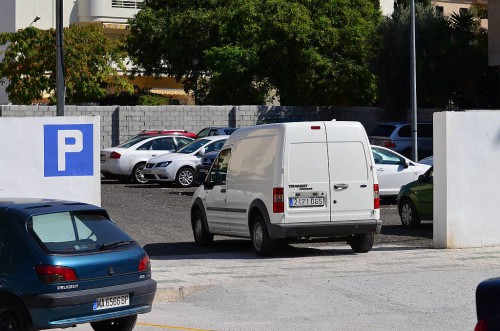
[0,25,133,104]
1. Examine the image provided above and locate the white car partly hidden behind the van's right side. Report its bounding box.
[371,145,431,196]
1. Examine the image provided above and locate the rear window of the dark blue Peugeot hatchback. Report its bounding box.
[28,211,135,254]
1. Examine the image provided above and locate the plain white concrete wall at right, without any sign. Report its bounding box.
[434,110,500,248]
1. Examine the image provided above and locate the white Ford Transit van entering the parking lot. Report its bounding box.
[191,121,382,256]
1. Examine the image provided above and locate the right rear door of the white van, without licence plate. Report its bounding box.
[326,122,374,222]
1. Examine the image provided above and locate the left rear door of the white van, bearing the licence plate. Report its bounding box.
[284,122,330,223]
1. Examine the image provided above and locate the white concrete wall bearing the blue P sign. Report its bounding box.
[0,116,101,206]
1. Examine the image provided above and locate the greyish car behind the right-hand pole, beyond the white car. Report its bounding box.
[368,122,432,158]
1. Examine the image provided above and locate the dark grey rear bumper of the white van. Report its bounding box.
[267,220,382,239]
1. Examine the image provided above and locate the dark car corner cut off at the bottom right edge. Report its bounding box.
[474,278,500,331]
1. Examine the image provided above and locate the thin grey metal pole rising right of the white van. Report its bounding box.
[410,0,418,162]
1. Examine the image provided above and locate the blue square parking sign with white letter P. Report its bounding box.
[43,124,94,177]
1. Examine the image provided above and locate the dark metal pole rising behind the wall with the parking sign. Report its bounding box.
[56,0,66,116]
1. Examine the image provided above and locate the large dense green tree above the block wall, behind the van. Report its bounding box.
[128,0,381,105]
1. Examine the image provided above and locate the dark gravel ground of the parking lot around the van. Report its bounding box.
[101,180,432,256]
